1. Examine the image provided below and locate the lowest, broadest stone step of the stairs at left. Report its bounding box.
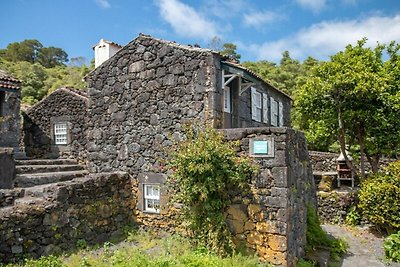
[15,170,88,187]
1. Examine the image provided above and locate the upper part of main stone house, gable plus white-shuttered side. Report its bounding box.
[86,34,292,173]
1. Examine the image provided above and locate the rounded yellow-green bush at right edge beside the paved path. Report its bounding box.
[358,161,400,233]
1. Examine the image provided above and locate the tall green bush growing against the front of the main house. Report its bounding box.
[168,126,256,254]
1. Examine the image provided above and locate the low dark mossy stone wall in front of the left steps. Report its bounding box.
[0,173,133,263]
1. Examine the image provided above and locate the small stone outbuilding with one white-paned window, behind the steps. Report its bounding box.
[23,88,88,161]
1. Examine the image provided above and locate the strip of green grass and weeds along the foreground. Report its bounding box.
[3,232,268,267]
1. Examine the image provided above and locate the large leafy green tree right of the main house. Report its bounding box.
[295,39,400,176]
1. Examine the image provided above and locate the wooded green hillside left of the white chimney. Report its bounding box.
[0,40,93,105]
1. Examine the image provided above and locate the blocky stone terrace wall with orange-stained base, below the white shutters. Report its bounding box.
[223,127,316,266]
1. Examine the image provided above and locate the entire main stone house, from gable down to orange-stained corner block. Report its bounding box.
[86,34,314,266]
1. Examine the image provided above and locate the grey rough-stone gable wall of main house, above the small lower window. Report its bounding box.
[87,35,216,175]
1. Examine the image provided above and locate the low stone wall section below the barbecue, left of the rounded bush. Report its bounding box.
[317,189,358,224]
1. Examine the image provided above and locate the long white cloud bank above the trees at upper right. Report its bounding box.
[250,14,400,61]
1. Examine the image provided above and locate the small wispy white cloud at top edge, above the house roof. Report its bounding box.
[156,0,218,40]
